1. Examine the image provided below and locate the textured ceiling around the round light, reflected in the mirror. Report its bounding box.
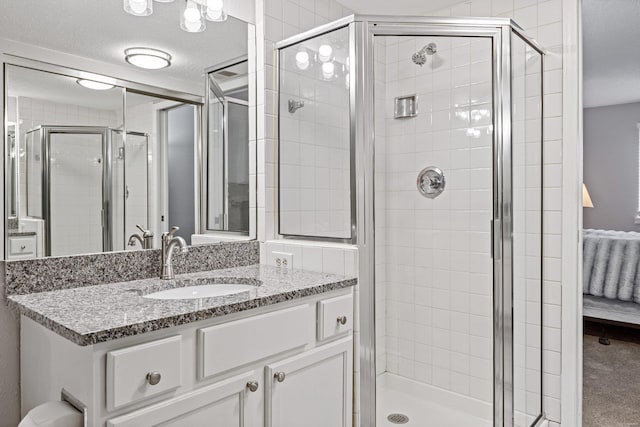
[0,0,247,94]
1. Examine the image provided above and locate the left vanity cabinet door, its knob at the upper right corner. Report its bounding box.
[107,371,264,427]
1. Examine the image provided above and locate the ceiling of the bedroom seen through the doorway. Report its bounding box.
[582,0,640,107]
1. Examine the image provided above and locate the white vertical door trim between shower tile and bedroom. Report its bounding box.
[556,0,583,426]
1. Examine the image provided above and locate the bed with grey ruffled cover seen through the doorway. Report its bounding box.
[583,229,640,325]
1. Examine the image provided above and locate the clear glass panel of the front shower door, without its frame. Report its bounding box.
[374,36,494,427]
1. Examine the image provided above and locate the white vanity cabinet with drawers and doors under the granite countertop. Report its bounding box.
[21,288,353,427]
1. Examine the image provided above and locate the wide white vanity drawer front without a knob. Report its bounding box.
[198,304,315,379]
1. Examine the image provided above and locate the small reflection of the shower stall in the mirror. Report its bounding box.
[24,126,149,256]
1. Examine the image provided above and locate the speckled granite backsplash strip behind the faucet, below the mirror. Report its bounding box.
[5,241,260,295]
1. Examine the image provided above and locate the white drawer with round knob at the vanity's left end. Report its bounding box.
[106,336,182,411]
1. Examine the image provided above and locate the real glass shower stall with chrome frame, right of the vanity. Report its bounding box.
[277,15,545,427]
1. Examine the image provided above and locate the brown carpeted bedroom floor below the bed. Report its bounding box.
[582,325,640,427]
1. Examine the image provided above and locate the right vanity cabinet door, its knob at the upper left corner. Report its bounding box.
[265,337,353,427]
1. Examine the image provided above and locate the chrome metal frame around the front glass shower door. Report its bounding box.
[352,16,545,427]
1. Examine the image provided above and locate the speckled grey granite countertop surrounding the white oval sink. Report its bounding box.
[7,264,357,346]
